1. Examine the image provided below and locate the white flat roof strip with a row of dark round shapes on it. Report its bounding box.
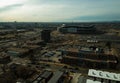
[88,69,120,81]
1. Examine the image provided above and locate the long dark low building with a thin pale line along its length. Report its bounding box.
[61,49,118,69]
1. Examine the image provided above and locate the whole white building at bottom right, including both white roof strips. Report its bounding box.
[86,69,120,83]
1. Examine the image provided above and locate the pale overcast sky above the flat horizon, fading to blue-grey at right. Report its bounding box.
[0,0,120,22]
